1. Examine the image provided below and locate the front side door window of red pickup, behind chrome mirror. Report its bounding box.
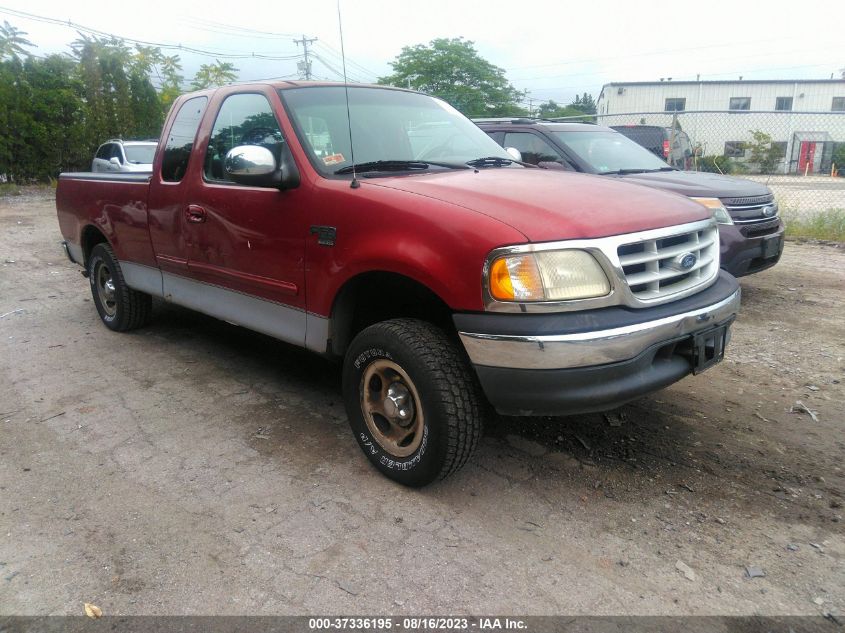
[204,94,284,182]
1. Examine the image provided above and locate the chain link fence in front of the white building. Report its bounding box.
[590,110,845,216]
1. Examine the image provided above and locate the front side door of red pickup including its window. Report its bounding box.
[182,90,307,316]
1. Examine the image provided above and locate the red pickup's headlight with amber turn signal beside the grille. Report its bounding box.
[488,249,610,302]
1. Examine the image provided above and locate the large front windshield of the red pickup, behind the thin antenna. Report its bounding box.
[279,86,512,176]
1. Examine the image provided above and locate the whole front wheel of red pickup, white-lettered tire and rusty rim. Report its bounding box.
[343,319,482,486]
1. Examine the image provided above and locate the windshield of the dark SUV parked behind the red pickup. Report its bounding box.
[553,130,671,174]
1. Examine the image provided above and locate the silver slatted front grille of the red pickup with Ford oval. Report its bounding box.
[617,226,719,301]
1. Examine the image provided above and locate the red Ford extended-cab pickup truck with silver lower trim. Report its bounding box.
[56,82,740,486]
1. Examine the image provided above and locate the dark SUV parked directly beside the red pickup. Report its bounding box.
[476,119,784,277]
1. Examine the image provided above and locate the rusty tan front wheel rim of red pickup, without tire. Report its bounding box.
[360,358,425,457]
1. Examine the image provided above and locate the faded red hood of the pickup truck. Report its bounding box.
[362,168,711,242]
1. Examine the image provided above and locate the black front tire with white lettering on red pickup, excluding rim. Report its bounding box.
[343,319,483,487]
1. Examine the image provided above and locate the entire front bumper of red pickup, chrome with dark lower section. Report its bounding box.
[454,272,740,415]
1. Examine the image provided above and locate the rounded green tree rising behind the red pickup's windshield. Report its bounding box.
[378,38,525,116]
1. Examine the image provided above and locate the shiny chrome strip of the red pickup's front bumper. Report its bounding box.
[459,289,741,369]
